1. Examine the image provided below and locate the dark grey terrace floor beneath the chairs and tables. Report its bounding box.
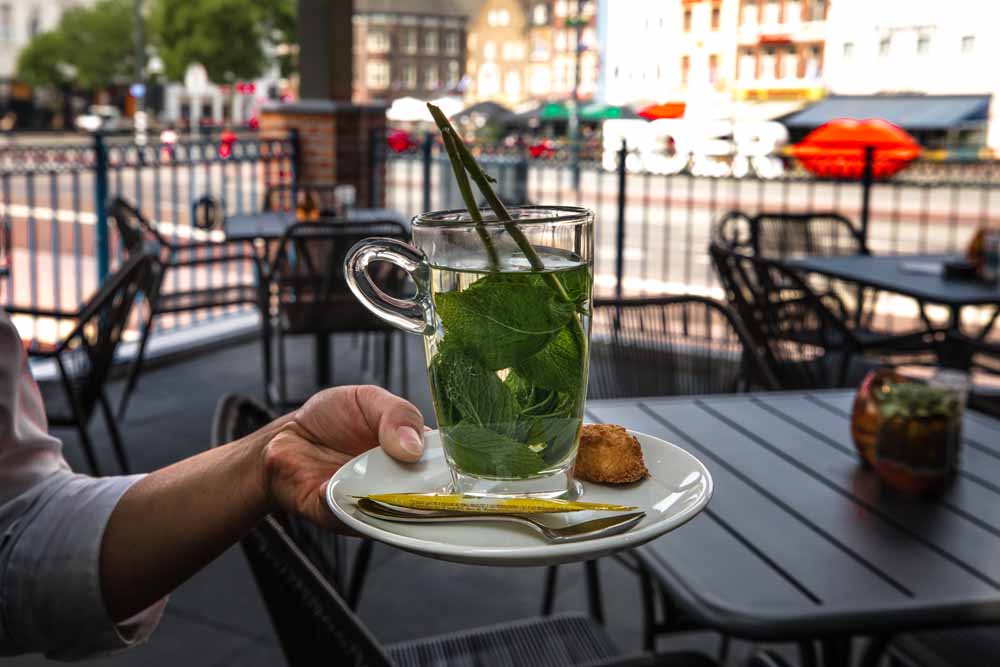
[0,336,792,667]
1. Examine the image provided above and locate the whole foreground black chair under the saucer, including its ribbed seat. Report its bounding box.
[212,395,715,667]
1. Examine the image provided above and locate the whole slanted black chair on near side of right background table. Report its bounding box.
[709,242,942,389]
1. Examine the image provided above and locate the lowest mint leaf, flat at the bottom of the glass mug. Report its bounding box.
[442,421,546,478]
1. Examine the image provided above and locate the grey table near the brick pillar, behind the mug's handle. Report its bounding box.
[223,208,409,388]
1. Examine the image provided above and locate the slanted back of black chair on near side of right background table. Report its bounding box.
[709,243,859,389]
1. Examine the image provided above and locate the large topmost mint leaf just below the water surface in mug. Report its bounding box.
[434,273,574,370]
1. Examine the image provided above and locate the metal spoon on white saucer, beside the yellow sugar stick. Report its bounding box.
[358,498,646,544]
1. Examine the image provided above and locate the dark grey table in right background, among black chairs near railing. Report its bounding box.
[783,254,1000,370]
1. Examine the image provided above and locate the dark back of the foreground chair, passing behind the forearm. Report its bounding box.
[212,394,393,667]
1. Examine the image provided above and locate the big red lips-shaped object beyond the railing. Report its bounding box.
[789,118,920,180]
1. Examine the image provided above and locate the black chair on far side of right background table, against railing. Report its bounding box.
[712,211,879,327]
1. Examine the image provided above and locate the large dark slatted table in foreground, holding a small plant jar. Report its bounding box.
[587,390,1000,665]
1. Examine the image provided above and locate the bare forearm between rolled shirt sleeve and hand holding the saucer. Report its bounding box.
[100,416,290,621]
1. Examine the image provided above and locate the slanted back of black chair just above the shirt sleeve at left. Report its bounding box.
[56,254,152,420]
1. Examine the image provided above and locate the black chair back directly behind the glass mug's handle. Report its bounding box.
[270,220,407,333]
